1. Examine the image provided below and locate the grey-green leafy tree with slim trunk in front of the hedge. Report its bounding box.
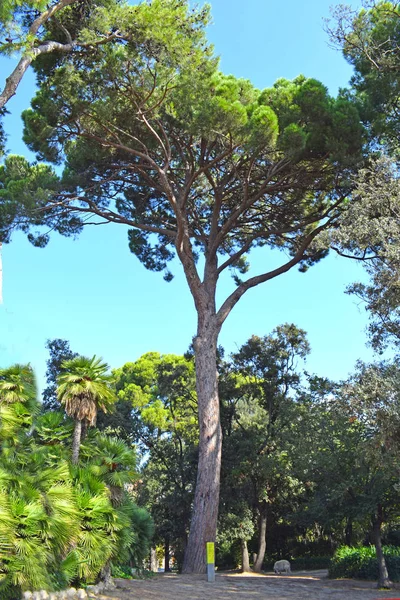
[295,365,398,587]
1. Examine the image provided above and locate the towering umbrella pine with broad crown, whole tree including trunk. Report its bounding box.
[0,2,362,571]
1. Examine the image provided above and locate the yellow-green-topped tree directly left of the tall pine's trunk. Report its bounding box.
[111,352,198,570]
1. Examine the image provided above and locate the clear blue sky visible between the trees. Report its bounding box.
[0,0,382,394]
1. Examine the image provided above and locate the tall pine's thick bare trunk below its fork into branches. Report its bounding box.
[182,314,222,573]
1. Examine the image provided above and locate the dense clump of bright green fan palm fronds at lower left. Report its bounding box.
[0,367,152,598]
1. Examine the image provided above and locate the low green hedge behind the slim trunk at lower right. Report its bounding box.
[329,546,400,581]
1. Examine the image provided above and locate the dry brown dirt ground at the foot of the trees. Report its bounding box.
[102,571,400,600]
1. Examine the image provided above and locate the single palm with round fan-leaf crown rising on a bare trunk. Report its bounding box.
[57,356,116,465]
